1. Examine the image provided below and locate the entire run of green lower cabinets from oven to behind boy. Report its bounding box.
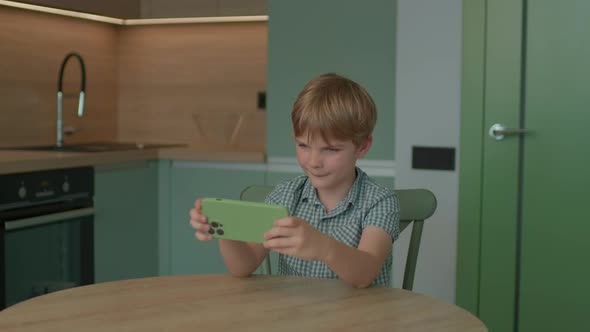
[95,160,393,282]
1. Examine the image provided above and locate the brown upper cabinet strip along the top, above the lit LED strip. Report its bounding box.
[13,0,268,19]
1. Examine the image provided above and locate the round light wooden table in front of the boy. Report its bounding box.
[0,275,487,332]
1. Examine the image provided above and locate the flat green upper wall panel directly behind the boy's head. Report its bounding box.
[267,0,395,160]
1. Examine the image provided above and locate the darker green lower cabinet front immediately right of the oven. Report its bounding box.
[94,161,158,282]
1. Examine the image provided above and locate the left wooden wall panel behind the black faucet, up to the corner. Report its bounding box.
[0,7,118,146]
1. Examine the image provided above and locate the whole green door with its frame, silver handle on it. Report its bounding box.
[457,0,590,332]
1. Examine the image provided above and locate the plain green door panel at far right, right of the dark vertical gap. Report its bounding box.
[518,0,590,331]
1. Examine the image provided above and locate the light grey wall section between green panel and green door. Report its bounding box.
[394,0,461,302]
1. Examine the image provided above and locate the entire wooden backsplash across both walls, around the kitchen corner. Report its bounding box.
[0,6,267,151]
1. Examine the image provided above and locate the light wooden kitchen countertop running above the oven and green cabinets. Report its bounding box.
[0,147,265,174]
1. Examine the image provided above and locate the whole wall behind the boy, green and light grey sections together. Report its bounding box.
[267,0,468,302]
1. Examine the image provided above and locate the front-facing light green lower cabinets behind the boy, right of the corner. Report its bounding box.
[157,161,393,275]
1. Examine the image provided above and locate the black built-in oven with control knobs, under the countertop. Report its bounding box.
[0,167,94,310]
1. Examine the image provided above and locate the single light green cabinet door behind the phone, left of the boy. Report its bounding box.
[168,162,265,275]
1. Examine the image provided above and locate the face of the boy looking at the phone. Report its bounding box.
[295,133,372,193]
